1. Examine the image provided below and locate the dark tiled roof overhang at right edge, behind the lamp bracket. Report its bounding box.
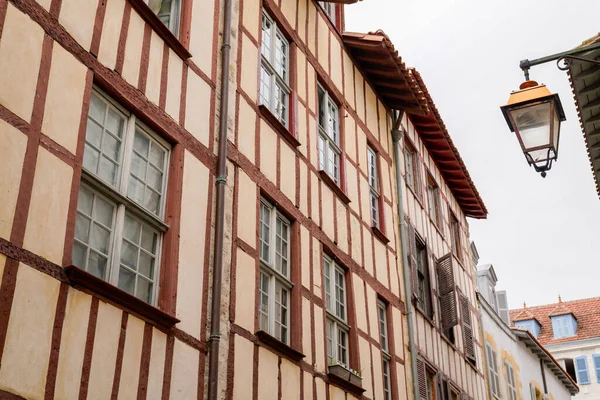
[568,35,600,196]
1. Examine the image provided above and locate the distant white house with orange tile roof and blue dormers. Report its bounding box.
[510,297,600,400]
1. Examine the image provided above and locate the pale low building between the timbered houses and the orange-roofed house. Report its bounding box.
[477,264,579,400]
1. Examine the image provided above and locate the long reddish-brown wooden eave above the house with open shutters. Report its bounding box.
[409,69,487,219]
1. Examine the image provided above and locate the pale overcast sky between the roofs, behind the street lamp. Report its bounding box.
[346,0,600,308]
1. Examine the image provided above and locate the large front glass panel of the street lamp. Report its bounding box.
[510,102,552,151]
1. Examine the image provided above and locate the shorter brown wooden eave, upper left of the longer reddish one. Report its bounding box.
[342,30,429,115]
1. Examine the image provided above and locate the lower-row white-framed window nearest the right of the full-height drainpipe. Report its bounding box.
[258,199,294,344]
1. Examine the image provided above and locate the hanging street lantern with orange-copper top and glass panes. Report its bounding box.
[500,80,565,177]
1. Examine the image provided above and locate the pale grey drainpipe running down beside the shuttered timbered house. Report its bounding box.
[392,111,419,400]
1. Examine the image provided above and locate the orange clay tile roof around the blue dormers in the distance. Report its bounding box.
[510,297,600,345]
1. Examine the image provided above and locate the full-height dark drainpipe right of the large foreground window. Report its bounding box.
[208,0,232,400]
